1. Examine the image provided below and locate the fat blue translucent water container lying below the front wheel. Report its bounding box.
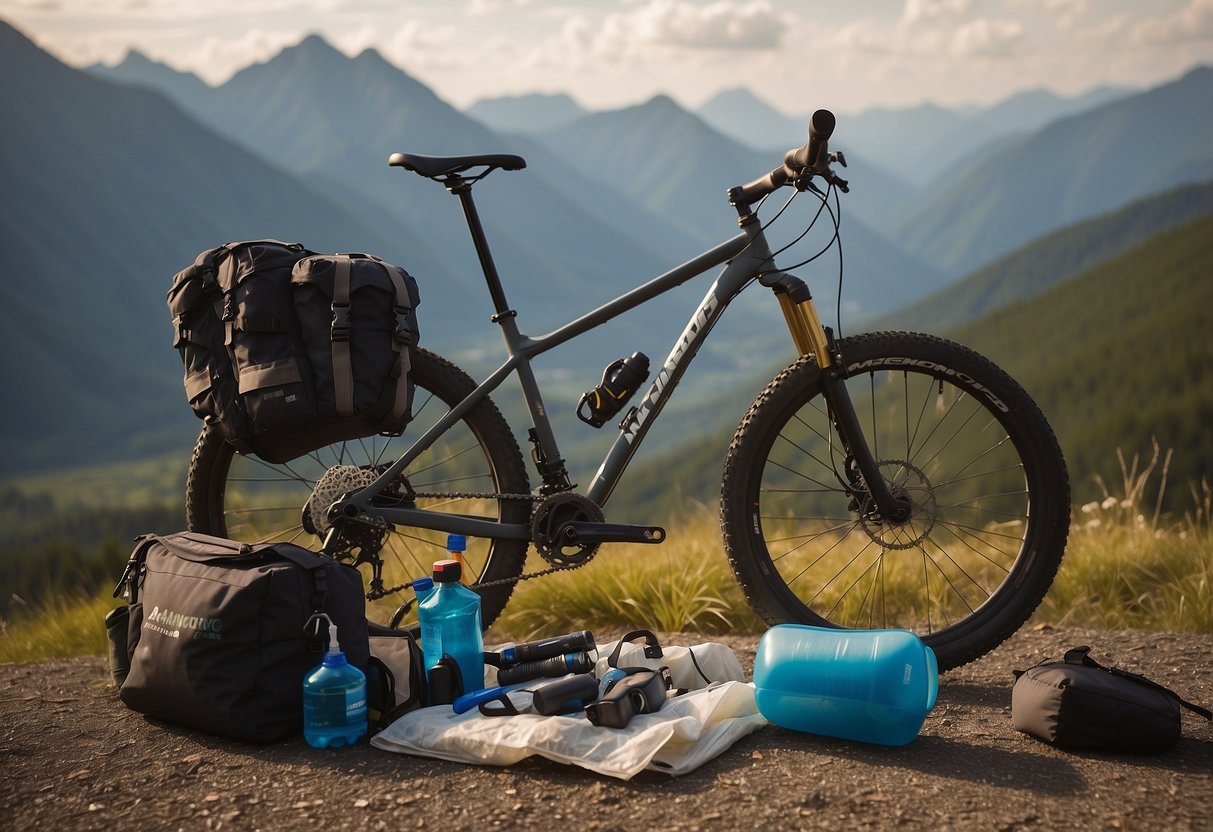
[754,625,939,746]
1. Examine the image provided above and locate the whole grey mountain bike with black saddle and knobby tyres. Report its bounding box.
[186,110,1070,668]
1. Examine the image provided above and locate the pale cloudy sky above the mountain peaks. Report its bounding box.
[0,0,1213,114]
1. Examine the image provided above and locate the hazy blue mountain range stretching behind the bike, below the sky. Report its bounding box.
[0,16,1213,492]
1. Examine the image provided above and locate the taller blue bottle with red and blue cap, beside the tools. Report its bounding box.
[417,560,484,694]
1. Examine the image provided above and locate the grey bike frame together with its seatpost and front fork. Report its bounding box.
[336,173,894,540]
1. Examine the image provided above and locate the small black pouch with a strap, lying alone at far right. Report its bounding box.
[1010,646,1211,753]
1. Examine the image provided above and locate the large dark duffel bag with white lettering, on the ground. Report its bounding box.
[107,532,369,742]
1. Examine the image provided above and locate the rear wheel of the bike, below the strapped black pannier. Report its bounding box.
[186,349,531,628]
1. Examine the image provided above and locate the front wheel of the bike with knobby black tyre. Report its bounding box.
[721,332,1070,669]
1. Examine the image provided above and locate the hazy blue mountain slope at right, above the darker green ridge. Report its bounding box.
[892,67,1213,275]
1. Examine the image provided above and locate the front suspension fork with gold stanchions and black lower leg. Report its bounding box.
[776,283,911,523]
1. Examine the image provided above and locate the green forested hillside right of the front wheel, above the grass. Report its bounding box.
[955,216,1213,511]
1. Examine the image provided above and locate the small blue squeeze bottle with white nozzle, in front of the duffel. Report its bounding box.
[303,616,366,748]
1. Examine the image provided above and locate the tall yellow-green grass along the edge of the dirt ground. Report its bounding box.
[0,446,1213,663]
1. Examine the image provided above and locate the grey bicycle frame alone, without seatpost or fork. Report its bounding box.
[341,222,774,540]
